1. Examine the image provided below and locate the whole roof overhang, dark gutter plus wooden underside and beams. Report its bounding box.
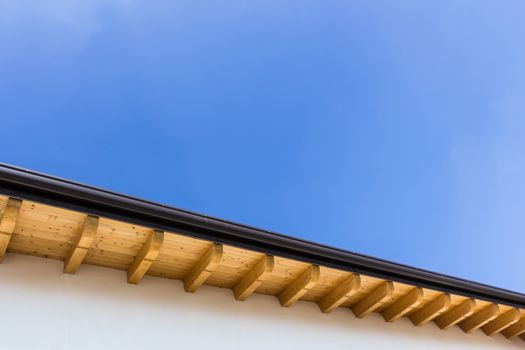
[0,164,525,338]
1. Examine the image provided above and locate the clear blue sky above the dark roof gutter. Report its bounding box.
[0,0,525,292]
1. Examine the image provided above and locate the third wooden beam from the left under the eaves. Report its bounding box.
[128,230,164,284]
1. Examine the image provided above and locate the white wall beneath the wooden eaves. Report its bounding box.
[0,254,525,350]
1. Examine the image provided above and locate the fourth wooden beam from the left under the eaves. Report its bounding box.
[183,243,222,293]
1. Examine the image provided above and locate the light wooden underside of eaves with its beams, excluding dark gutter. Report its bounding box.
[0,195,525,344]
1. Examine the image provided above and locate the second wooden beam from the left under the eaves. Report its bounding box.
[64,215,98,273]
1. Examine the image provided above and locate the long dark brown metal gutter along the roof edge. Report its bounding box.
[0,163,525,308]
